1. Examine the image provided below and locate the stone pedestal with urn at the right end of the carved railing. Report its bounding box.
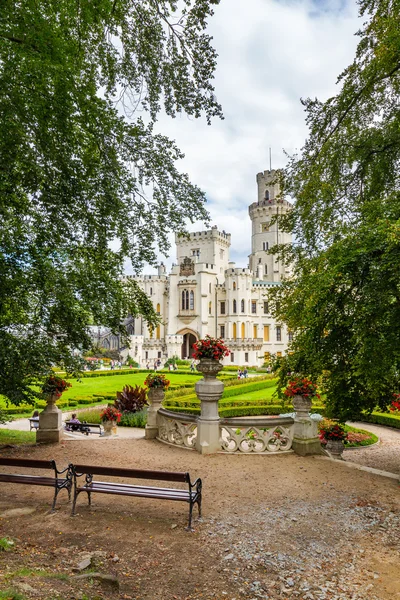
[292,396,324,456]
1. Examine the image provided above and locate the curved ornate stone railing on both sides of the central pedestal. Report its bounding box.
[157,408,294,454]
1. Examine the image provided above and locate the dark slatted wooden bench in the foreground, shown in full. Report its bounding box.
[71,465,202,530]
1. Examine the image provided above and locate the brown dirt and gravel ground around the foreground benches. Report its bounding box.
[0,439,400,600]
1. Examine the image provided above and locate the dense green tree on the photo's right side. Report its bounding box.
[274,0,400,417]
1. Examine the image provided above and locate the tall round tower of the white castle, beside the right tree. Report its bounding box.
[249,170,292,282]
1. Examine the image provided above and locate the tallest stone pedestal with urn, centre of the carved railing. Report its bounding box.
[195,358,224,454]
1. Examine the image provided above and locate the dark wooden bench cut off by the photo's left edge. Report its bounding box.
[0,456,72,512]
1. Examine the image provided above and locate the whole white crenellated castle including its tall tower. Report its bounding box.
[97,171,291,367]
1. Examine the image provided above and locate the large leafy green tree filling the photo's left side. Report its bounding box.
[0,0,222,402]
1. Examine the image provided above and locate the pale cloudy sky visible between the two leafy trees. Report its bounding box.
[133,0,362,274]
